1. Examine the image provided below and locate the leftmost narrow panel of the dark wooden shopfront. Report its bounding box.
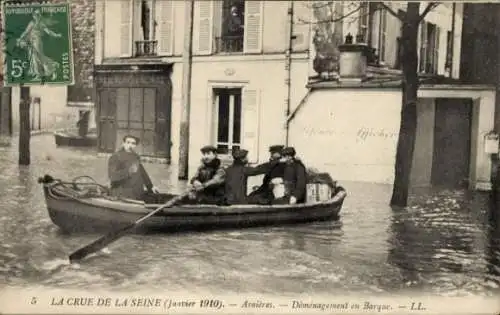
[97,88,116,152]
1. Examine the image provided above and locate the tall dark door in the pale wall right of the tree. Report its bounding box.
[432,99,472,188]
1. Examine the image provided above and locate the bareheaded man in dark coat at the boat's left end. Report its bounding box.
[108,135,158,200]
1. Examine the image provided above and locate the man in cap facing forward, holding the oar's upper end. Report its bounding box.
[189,145,226,204]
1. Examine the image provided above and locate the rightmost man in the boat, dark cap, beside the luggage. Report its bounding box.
[273,147,307,205]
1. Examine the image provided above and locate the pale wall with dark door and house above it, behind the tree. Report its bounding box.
[290,2,495,190]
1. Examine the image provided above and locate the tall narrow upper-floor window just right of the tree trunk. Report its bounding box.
[419,22,439,74]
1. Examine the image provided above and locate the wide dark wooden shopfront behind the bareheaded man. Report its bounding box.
[96,65,172,160]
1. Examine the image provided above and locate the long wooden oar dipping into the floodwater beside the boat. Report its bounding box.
[69,191,189,263]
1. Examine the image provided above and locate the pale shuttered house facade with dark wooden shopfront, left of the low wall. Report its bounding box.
[96,0,310,171]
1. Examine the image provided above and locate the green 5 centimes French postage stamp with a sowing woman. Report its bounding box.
[2,2,74,86]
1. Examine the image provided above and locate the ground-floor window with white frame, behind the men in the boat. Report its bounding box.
[213,88,242,154]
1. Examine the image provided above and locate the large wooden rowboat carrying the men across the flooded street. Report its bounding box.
[39,175,347,233]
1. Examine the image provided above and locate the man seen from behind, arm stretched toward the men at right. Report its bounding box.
[224,149,278,205]
